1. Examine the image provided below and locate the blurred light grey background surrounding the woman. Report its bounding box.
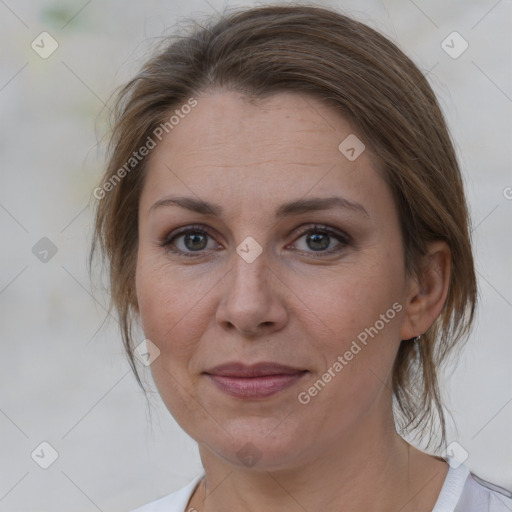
[0,0,512,512]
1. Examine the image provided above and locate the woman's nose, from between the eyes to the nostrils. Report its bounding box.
[216,247,288,337]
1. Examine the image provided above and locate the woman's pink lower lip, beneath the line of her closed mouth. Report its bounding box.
[208,372,305,398]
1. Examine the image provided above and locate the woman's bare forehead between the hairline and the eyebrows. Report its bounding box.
[142,92,385,214]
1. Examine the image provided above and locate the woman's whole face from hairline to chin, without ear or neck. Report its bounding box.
[136,92,408,468]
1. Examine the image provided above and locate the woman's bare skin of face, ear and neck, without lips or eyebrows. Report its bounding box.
[136,91,450,512]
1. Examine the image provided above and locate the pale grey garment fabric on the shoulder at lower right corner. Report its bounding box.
[455,473,512,512]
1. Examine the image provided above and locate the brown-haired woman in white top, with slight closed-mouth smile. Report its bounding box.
[93,6,512,512]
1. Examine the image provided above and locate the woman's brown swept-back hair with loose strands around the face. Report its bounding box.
[89,5,477,447]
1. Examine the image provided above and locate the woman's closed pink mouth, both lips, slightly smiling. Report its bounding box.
[204,363,308,399]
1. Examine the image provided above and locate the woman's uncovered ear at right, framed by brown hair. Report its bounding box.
[400,241,451,340]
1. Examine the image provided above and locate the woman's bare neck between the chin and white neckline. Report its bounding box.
[187,402,448,512]
